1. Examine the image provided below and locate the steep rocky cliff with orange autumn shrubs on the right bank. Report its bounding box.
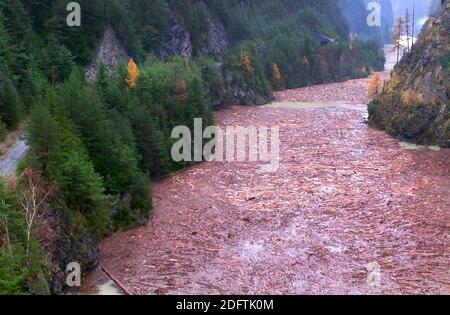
[369,0,450,147]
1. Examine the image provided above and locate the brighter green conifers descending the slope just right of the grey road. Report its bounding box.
[27,106,111,236]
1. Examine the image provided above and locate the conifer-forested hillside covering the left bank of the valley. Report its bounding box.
[0,0,384,293]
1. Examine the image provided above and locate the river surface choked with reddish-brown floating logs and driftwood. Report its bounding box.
[83,80,450,294]
